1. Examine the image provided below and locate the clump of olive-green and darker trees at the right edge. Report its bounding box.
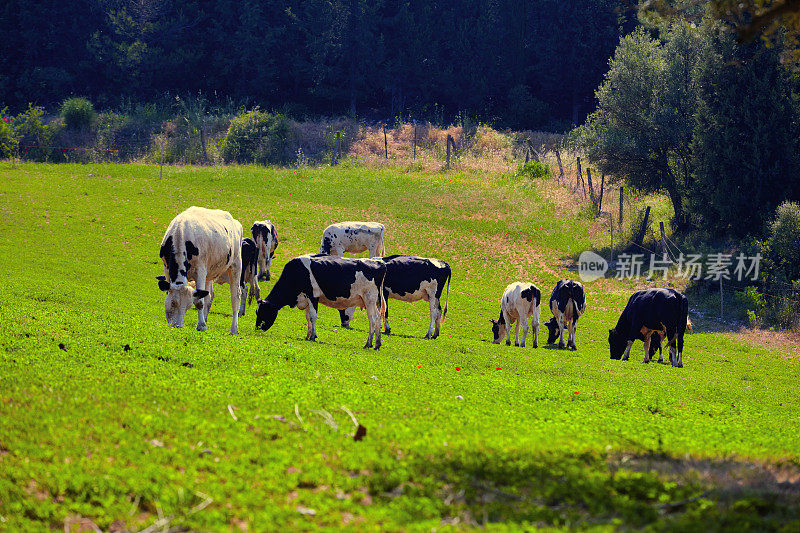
[577,23,800,237]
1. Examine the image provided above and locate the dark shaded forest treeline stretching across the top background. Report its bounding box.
[0,0,636,129]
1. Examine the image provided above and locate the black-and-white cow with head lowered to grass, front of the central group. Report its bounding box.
[256,254,386,350]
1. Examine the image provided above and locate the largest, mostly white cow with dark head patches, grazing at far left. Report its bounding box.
[157,206,242,335]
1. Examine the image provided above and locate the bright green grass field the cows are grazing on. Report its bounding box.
[0,162,800,531]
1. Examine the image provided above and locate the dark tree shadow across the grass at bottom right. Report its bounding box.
[371,449,800,531]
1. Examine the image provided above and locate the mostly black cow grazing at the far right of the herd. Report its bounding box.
[608,289,690,367]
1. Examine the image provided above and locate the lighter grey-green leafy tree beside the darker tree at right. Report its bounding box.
[578,25,702,227]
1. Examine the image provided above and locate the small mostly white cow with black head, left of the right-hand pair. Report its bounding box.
[490,281,542,348]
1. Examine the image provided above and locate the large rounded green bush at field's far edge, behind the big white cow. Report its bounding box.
[220,109,296,165]
